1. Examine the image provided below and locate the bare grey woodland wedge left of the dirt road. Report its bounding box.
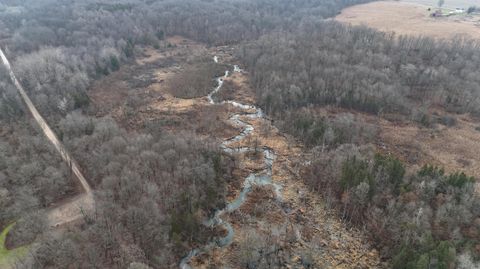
[0,65,77,244]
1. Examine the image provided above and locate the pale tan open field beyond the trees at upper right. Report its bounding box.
[335,1,480,39]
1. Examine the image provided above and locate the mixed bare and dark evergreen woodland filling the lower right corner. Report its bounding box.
[304,144,480,269]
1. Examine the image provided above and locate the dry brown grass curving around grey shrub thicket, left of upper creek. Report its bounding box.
[89,36,223,131]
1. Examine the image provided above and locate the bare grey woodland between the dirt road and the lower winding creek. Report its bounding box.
[24,113,234,268]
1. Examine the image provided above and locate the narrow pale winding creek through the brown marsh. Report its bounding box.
[180,56,282,269]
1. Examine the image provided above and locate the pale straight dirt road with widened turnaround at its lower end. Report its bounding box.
[0,48,94,227]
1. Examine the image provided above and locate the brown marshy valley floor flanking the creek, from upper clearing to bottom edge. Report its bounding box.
[90,37,382,268]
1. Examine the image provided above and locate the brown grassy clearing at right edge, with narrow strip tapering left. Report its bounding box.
[287,106,480,178]
